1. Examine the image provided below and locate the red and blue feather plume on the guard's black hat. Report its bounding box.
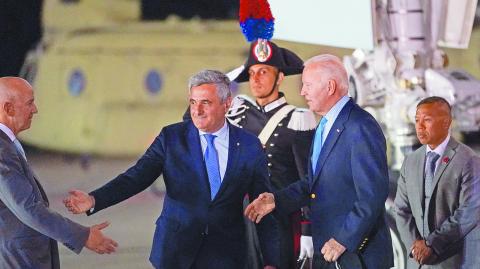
[239,0,275,42]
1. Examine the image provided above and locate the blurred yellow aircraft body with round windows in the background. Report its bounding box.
[21,0,332,156]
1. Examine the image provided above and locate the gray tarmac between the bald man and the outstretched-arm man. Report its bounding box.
[27,150,163,269]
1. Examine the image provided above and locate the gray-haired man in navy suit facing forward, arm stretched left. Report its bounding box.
[64,70,279,269]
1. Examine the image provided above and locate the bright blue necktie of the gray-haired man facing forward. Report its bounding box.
[204,134,222,200]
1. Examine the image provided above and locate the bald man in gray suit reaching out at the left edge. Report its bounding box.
[0,77,117,269]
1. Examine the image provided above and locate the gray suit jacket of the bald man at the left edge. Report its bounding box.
[0,130,89,269]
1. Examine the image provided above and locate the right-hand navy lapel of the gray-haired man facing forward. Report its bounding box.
[213,123,240,201]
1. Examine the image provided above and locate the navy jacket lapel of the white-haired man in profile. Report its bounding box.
[310,100,353,188]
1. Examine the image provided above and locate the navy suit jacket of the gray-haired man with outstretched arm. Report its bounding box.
[91,120,278,269]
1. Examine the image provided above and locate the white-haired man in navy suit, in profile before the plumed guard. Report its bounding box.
[245,54,393,269]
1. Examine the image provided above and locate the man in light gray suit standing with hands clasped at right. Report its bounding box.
[395,97,480,269]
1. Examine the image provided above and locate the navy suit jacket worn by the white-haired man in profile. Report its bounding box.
[275,100,393,269]
